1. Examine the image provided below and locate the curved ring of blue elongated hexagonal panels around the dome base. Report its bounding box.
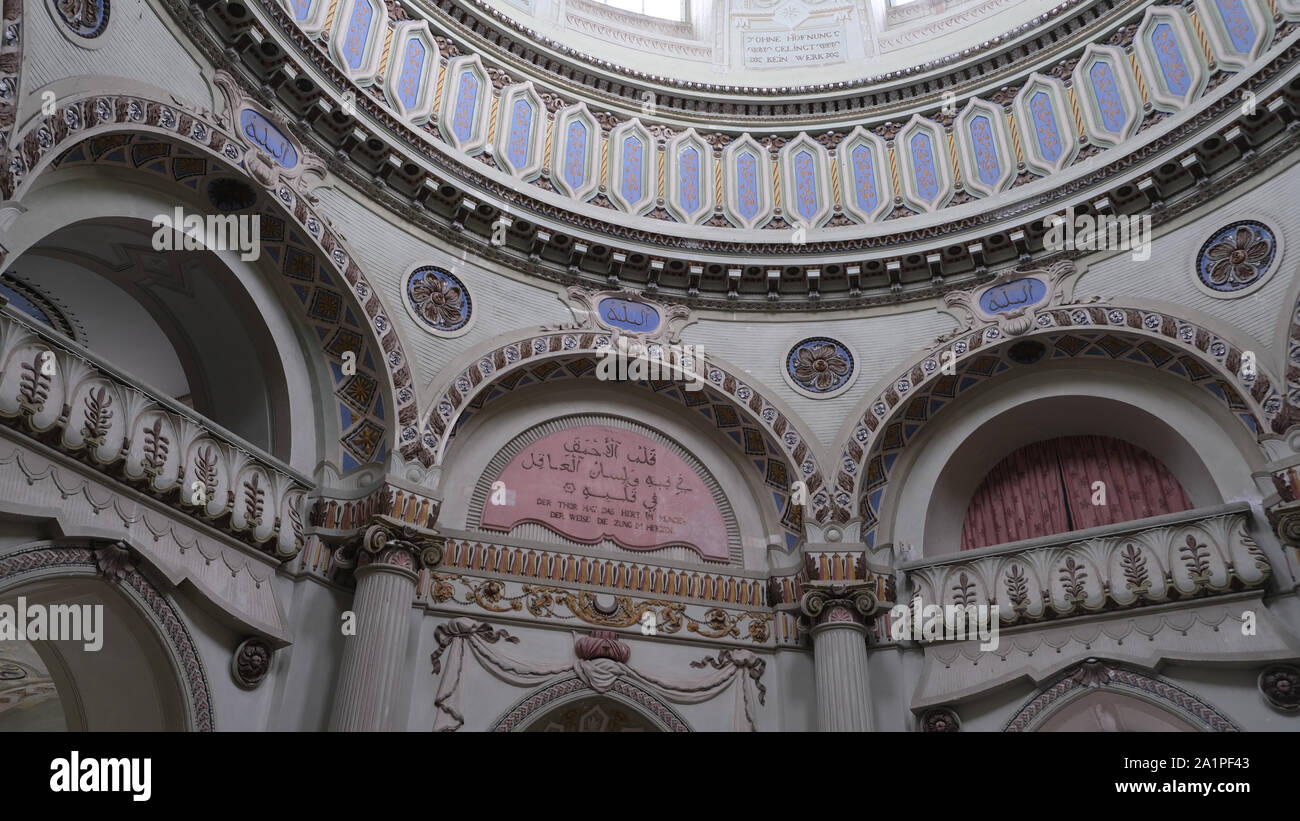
[268,0,1290,231]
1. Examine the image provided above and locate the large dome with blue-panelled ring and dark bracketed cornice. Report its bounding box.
[208,0,1300,308]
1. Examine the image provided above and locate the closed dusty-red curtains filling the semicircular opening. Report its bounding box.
[962,436,1192,549]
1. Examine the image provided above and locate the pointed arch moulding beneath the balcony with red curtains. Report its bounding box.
[1002,659,1240,733]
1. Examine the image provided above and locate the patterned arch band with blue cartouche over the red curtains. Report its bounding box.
[837,262,1283,546]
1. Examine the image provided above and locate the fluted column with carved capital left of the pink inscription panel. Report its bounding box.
[330,517,442,731]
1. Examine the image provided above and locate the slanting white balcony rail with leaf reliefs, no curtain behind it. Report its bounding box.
[0,297,311,559]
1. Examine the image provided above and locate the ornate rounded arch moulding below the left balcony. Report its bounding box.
[0,543,216,731]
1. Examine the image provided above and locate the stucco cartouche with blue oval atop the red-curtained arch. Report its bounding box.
[937,260,1101,343]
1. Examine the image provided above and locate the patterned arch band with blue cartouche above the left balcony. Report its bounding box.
[0,80,430,469]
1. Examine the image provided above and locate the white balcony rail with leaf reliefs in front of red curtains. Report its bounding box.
[901,501,1273,626]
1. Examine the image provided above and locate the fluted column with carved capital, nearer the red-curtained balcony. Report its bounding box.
[800,582,879,733]
